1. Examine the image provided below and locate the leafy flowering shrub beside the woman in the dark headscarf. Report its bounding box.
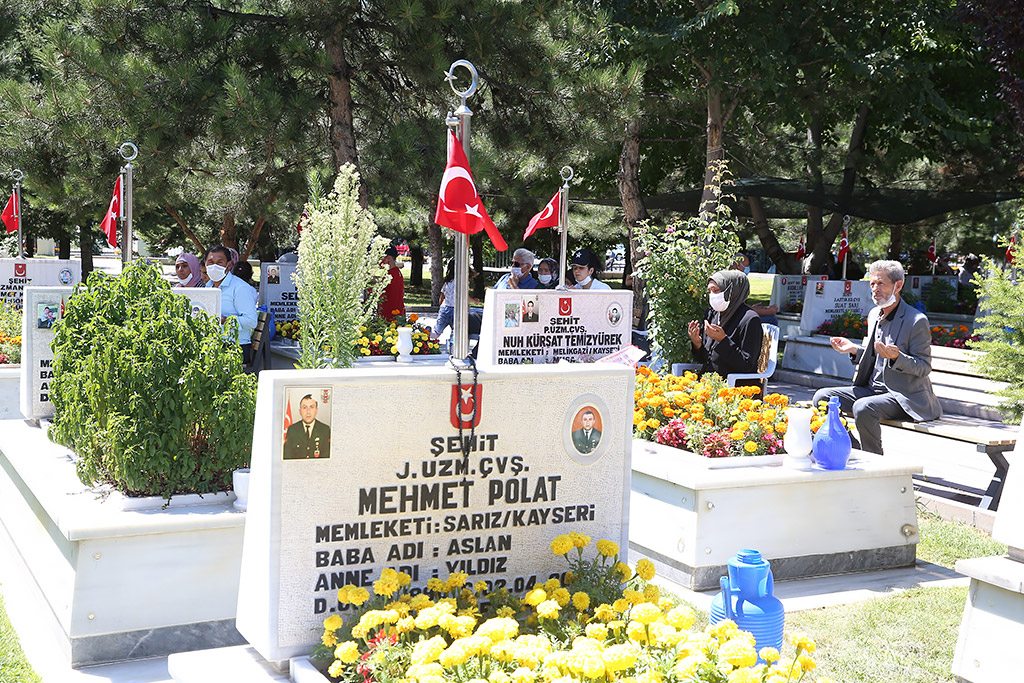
[637,165,739,362]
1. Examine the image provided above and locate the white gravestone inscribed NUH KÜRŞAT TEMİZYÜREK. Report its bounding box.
[477,290,633,366]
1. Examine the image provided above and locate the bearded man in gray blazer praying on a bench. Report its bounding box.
[814,261,942,454]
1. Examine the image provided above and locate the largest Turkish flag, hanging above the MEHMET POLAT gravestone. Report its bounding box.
[434,130,509,251]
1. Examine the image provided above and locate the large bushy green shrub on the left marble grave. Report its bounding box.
[50,261,256,498]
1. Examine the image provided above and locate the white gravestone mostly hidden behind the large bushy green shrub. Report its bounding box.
[20,287,221,420]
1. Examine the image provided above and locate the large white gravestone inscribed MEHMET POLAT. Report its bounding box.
[237,366,634,663]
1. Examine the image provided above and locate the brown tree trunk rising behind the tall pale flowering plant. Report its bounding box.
[324,25,367,209]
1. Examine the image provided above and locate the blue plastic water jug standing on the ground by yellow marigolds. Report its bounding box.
[711,550,785,651]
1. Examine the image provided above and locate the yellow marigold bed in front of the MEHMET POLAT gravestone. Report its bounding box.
[313,532,830,683]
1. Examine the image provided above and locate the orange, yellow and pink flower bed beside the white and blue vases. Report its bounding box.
[633,367,790,458]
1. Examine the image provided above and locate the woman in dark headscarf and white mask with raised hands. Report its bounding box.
[687,270,764,386]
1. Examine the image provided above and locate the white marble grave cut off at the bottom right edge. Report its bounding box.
[952,423,1024,683]
